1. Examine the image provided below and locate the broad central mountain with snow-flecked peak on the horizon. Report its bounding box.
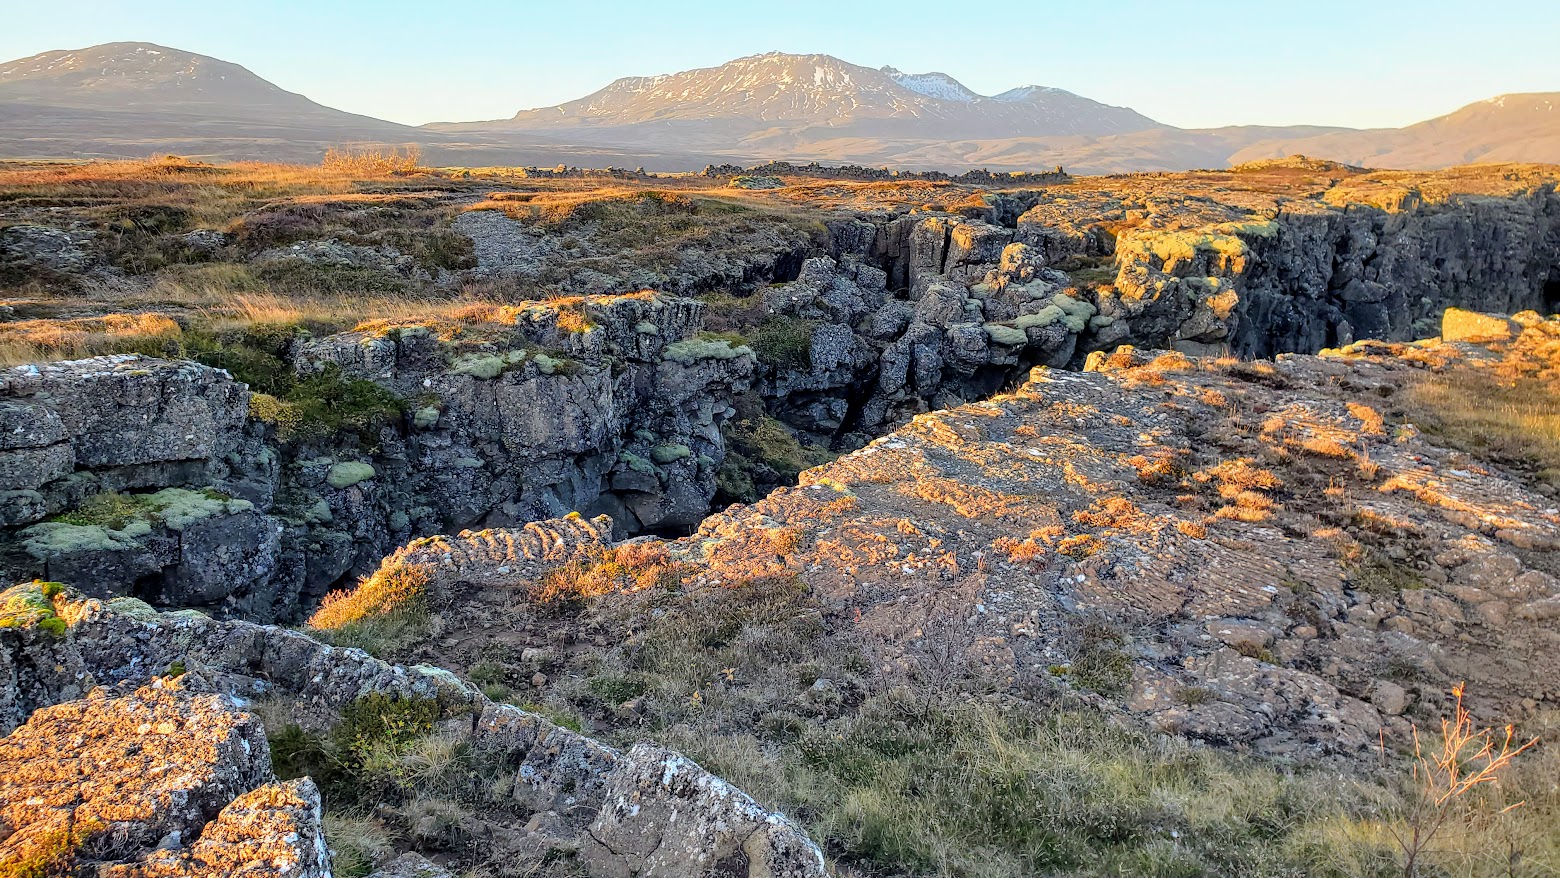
[431,51,1162,156]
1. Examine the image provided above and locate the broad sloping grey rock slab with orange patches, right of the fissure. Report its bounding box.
[652,317,1560,755]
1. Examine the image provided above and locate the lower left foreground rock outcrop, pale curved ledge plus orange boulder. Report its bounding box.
[0,583,825,878]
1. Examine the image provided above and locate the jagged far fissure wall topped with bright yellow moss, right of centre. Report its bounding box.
[739,167,1560,448]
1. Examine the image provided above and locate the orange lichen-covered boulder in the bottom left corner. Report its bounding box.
[0,680,329,878]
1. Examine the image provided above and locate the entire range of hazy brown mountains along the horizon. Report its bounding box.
[0,42,1560,173]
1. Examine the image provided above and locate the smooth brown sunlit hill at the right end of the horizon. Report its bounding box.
[1229,92,1560,168]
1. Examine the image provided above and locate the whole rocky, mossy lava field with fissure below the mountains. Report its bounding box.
[0,161,1560,875]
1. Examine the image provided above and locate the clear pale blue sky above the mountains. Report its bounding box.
[0,0,1560,128]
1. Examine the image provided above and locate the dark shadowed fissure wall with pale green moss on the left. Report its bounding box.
[0,293,753,619]
